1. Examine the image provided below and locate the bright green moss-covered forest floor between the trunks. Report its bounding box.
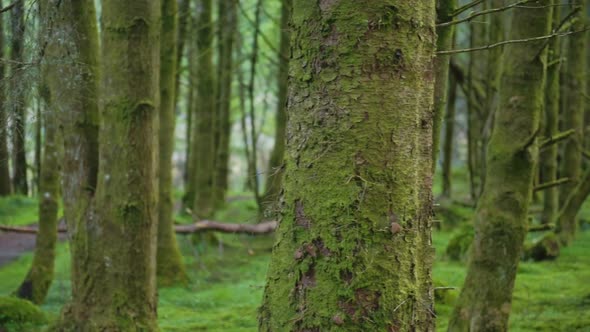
[0,172,590,332]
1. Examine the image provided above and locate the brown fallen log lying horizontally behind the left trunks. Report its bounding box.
[0,220,277,235]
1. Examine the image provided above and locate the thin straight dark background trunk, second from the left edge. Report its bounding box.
[10,0,29,195]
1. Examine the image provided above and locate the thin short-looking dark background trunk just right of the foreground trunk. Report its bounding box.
[442,71,457,198]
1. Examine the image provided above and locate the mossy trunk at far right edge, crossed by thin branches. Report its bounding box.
[559,0,590,244]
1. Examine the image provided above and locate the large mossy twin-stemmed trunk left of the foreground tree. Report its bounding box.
[50,0,161,331]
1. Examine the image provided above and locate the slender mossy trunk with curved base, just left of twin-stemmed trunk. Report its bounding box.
[16,34,62,304]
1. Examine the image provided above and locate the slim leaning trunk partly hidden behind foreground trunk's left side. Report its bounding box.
[263,0,293,209]
